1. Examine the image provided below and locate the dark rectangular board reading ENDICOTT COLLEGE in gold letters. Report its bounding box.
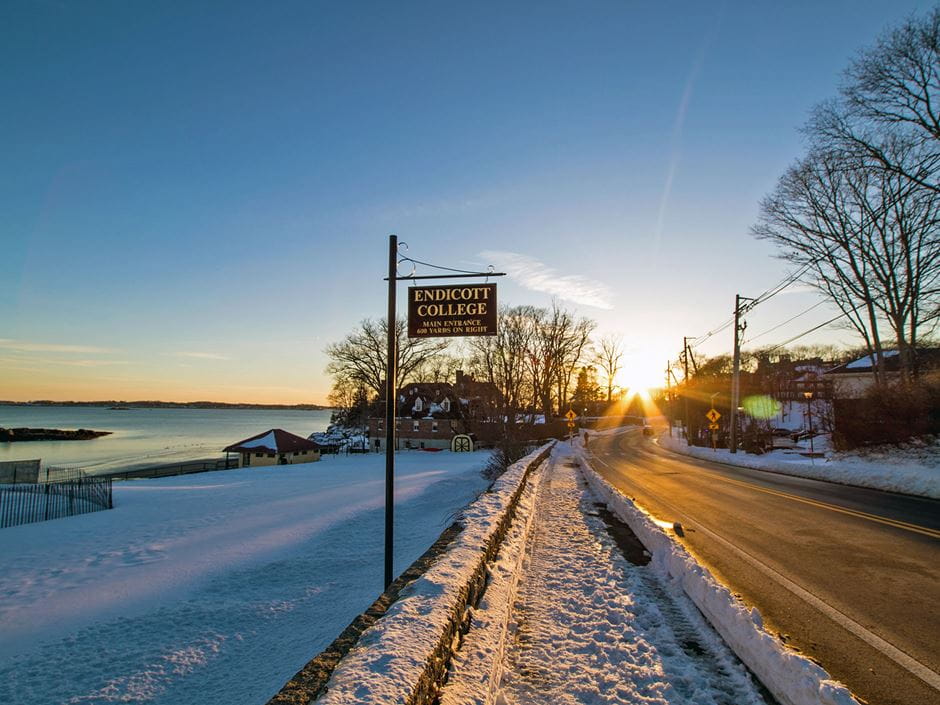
[408,284,496,338]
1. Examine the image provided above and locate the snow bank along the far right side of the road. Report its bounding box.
[659,434,940,499]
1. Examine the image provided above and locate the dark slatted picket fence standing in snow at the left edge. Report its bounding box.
[0,476,114,529]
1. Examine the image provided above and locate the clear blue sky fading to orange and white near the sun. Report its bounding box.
[0,1,930,402]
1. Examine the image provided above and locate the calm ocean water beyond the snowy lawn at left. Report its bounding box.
[0,405,331,472]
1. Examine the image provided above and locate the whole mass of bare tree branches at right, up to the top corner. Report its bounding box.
[753,8,940,384]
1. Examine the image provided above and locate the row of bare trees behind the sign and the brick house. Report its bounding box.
[325,302,623,425]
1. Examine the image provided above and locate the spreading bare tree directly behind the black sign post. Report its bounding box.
[325,318,449,398]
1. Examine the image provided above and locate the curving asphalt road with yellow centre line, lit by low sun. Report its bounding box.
[589,431,940,705]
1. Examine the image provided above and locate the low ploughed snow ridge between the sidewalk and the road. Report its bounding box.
[581,453,857,705]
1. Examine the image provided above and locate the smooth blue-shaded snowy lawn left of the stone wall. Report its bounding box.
[0,452,488,705]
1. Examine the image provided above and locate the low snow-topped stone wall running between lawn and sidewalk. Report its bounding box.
[268,442,554,705]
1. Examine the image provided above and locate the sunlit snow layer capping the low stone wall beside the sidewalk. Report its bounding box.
[317,444,552,705]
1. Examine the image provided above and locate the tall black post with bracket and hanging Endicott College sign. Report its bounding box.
[385,235,506,590]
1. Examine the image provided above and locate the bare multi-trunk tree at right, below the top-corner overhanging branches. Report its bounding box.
[752,144,940,383]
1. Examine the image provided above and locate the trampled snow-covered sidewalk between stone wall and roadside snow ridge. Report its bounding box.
[442,444,765,705]
